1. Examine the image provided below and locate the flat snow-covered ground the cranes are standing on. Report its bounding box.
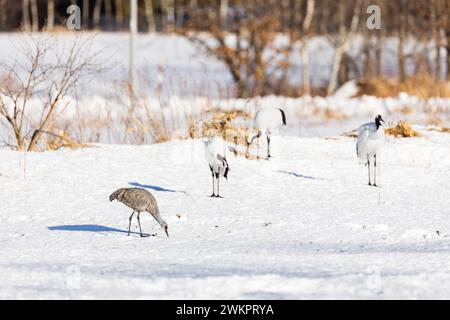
[0,132,450,299]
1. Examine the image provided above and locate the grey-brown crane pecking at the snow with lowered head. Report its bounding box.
[109,188,169,237]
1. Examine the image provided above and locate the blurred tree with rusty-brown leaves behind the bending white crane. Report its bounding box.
[184,1,292,97]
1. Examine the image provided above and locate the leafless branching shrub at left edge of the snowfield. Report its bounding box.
[0,38,101,151]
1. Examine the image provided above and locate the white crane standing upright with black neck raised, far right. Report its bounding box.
[356,115,385,187]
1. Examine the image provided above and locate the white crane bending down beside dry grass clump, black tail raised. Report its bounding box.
[247,107,286,159]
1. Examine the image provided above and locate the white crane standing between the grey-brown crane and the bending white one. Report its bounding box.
[205,137,230,198]
